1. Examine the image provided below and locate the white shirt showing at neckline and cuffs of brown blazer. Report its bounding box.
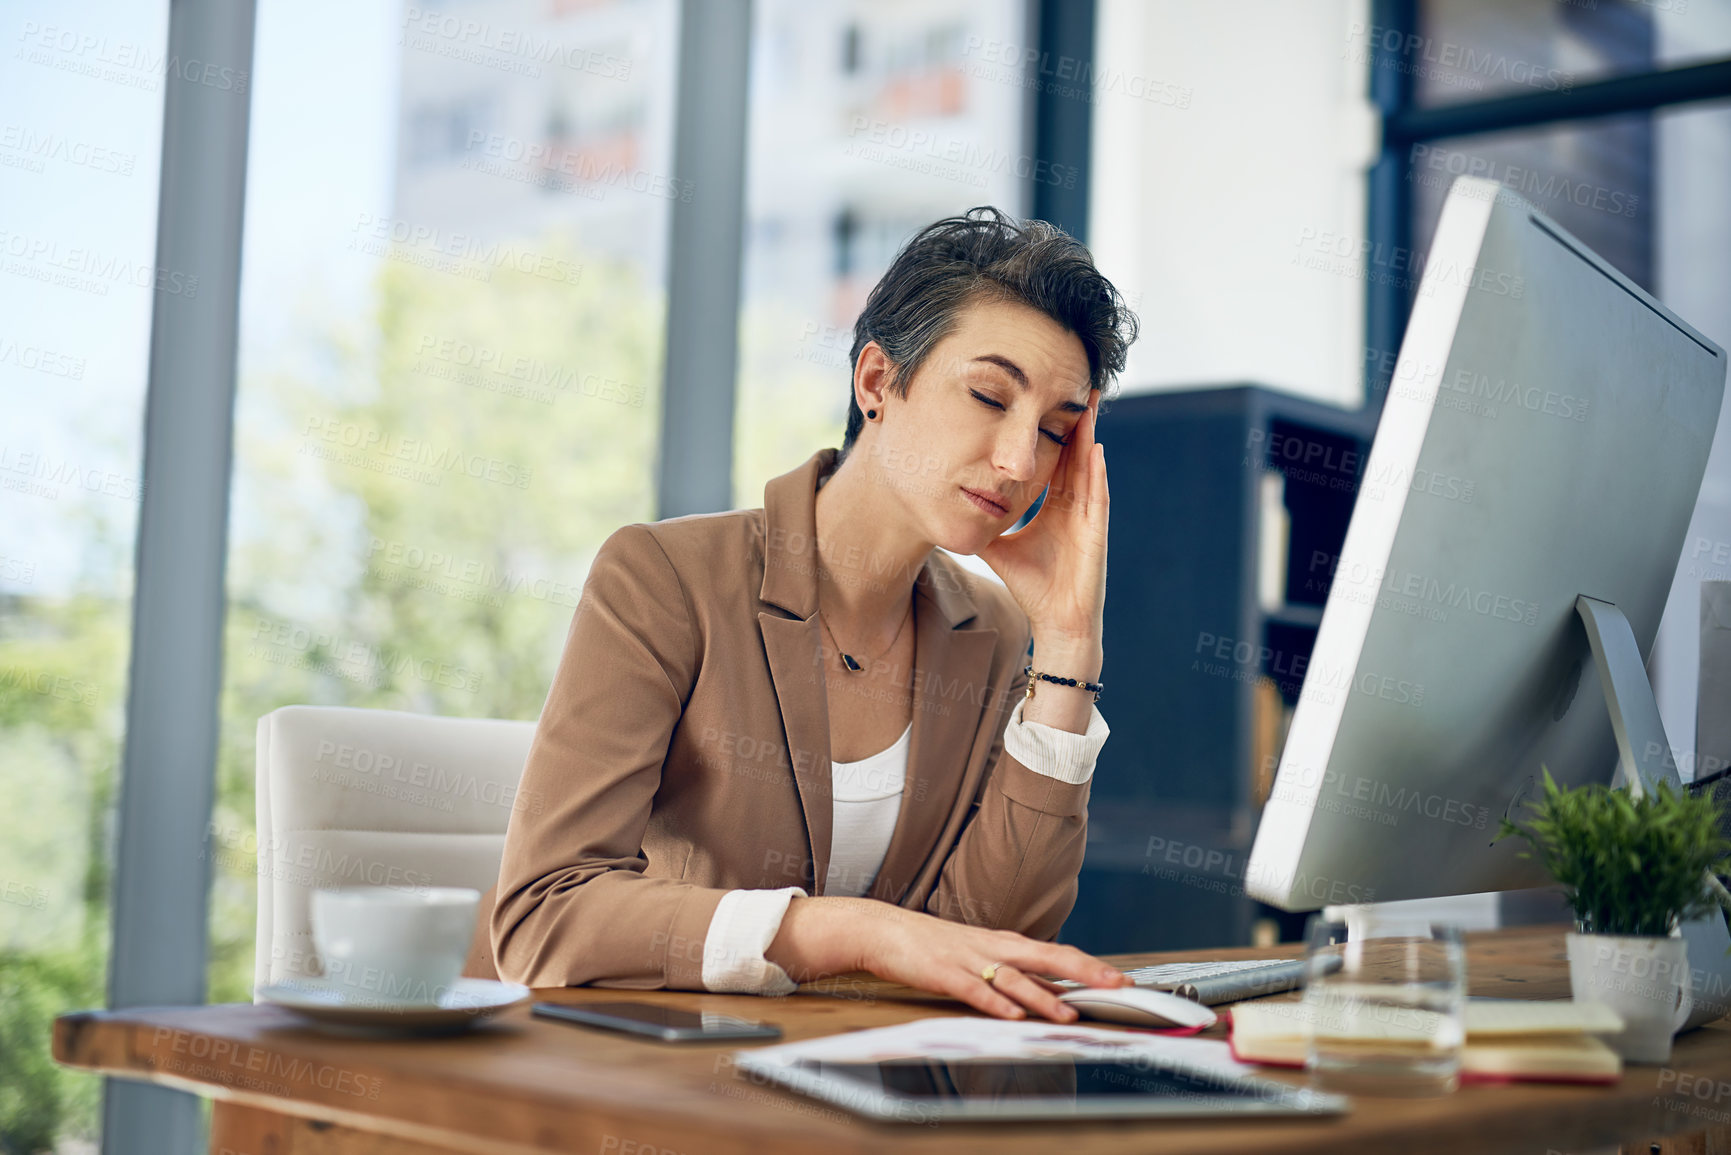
[703,698,1111,994]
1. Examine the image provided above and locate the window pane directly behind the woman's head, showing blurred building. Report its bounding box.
[734,0,1024,507]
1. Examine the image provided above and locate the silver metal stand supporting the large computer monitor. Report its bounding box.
[1575,594,1731,1030]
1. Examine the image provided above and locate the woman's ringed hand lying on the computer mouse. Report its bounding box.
[763,897,1130,1023]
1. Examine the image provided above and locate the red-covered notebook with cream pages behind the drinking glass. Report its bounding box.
[1232,999,1624,1082]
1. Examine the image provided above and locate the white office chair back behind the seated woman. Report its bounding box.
[253,707,544,987]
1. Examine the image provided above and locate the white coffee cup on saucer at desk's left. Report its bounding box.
[312,887,481,1006]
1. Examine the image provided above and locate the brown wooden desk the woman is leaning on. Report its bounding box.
[54,926,1731,1155]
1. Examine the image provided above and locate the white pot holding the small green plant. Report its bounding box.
[1568,933,1695,1063]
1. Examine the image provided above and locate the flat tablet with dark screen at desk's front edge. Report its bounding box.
[737,1051,1348,1122]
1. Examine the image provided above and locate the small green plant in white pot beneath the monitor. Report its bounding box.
[1499,769,1731,1063]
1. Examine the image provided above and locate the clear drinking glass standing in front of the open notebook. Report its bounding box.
[1303,914,1466,1096]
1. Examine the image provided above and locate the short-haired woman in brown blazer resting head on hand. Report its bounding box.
[490,210,1136,1022]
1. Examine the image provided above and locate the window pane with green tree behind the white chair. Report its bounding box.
[209,0,680,1001]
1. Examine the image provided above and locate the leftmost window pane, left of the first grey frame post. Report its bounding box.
[0,0,170,1152]
